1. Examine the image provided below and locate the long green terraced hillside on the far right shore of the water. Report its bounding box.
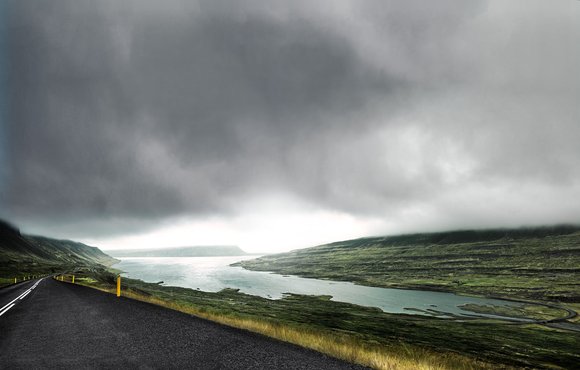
[238,226,580,302]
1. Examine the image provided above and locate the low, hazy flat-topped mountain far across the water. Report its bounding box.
[107,245,247,257]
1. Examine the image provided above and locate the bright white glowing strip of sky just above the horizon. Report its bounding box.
[83,211,386,253]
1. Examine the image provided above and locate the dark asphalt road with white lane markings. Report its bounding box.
[0,278,368,369]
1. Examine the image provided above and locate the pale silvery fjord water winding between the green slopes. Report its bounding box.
[114,256,518,317]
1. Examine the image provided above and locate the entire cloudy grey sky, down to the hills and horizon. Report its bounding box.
[0,0,580,252]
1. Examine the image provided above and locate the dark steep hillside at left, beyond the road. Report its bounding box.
[0,220,118,277]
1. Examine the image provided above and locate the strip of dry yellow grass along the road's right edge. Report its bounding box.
[75,283,511,370]
